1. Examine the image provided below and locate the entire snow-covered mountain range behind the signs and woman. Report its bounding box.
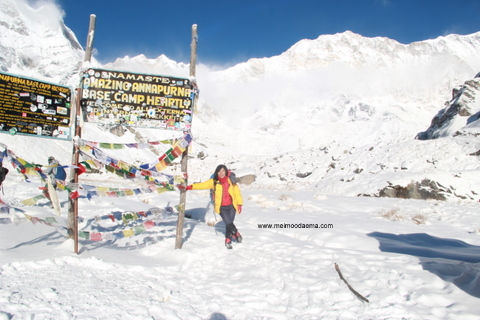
[0,0,480,199]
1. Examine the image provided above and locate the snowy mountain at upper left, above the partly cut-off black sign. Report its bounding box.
[0,0,83,84]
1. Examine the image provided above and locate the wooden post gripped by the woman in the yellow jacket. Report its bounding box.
[175,24,198,249]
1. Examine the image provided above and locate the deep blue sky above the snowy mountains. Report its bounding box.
[56,0,480,66]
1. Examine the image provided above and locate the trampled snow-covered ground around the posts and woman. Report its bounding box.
[0,131,480,319]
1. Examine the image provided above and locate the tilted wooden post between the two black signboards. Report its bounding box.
[68,14,96,254]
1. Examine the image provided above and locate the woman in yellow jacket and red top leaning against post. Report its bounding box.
[180,164,243,249]
